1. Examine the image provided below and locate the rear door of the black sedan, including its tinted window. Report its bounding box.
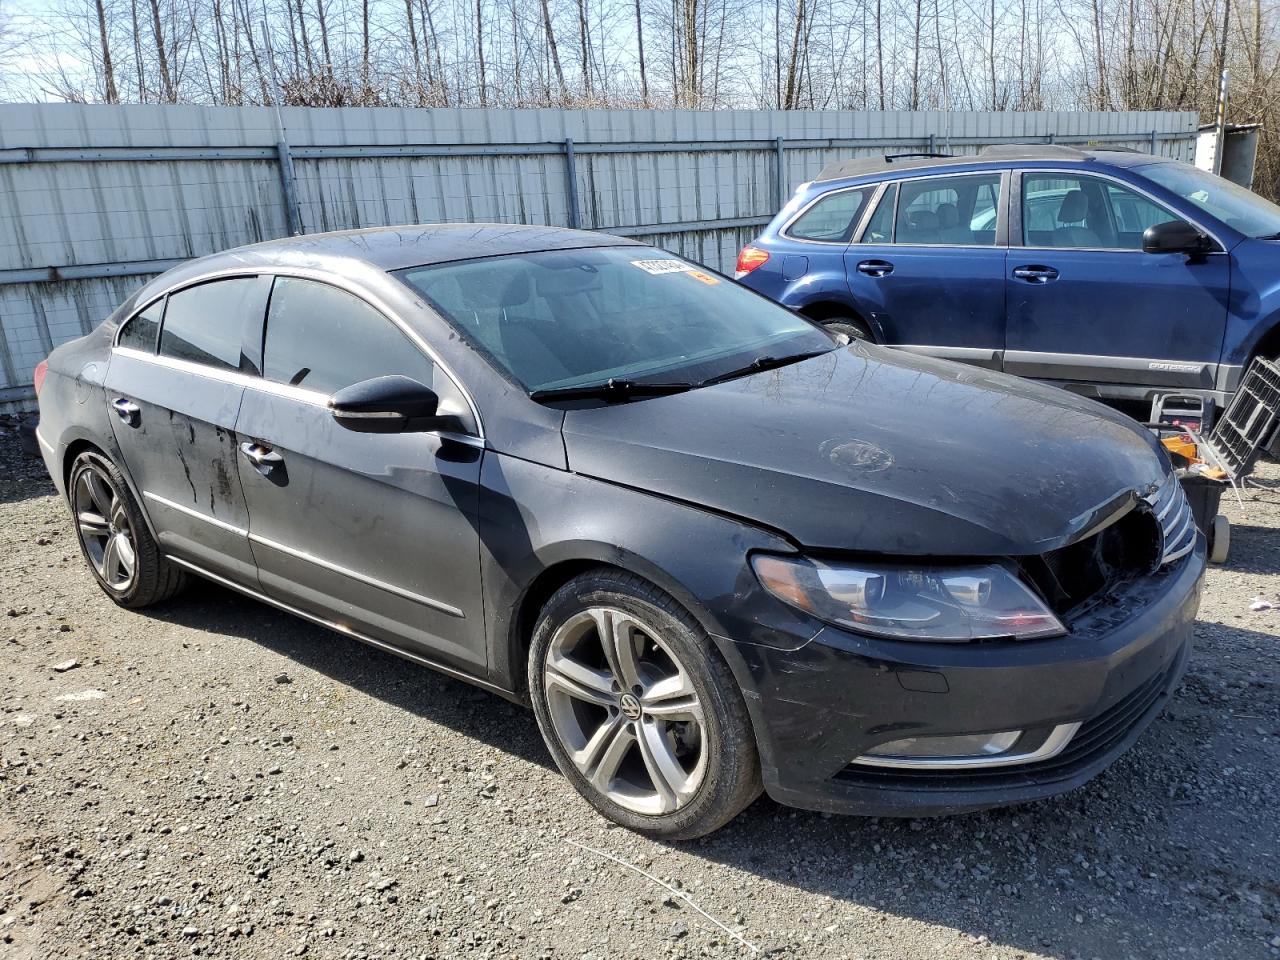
[105,276,270,585]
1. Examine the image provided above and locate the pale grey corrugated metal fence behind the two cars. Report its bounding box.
[0,104,1197,410]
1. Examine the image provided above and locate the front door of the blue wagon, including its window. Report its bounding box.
[1005,170,1230,392]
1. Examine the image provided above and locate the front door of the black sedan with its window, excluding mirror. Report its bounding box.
[236,276,488,673]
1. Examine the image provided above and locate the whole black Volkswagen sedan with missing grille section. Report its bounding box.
[37,225,1204,838]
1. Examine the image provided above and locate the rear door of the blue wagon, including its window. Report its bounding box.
[845,172,1009,369]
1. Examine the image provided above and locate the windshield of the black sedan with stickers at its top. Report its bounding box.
[397,252,836,396]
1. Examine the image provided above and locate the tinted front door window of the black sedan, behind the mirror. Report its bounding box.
[262,276,434,393]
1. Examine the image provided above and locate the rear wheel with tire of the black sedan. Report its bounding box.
[67,451,187,609]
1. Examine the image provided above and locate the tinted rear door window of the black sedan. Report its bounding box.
[160,276,261,370]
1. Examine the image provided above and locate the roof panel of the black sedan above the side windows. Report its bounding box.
[186,223,643,271]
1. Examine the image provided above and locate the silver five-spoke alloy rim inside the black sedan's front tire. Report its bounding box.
[543,607,708,815]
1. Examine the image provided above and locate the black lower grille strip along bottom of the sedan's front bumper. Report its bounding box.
[836,653,1185,794]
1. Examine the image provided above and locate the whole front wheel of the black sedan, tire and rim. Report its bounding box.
[529,570,760,840]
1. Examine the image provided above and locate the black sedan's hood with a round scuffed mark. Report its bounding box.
[564,344,1166,556]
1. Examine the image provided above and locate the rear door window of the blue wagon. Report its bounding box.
[893,174,1000,247]
